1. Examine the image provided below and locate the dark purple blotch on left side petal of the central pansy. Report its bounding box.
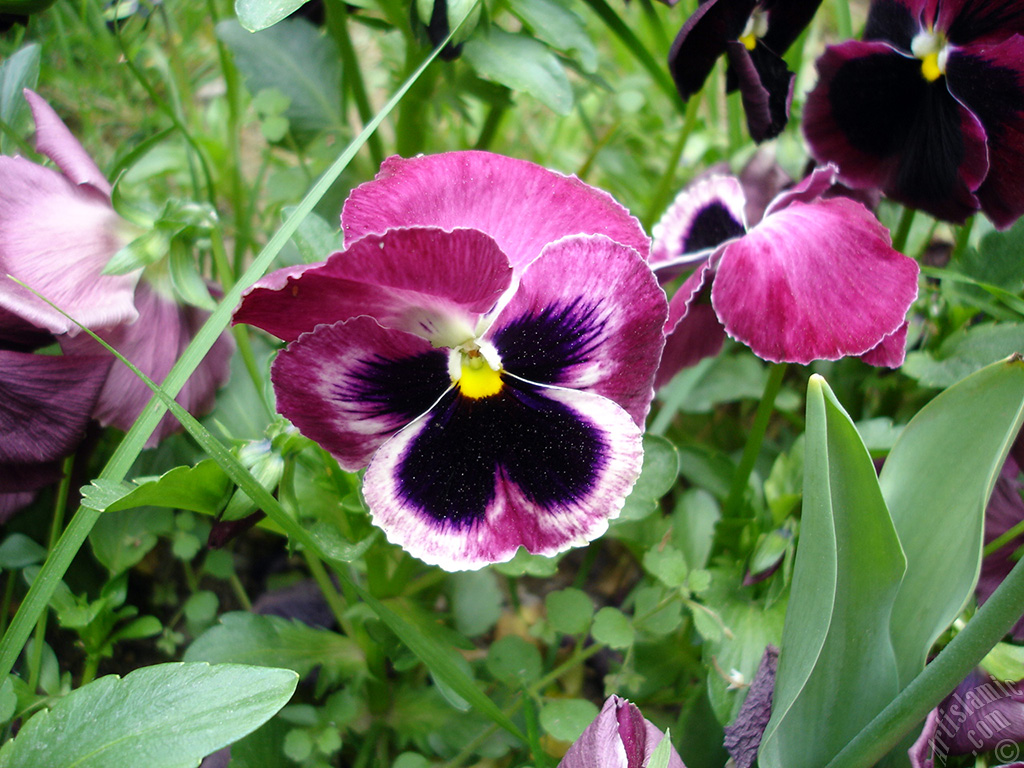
[334,349,452,422]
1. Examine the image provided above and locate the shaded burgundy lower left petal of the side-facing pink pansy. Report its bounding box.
[654,263,725,389]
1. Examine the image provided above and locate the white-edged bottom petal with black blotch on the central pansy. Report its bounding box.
[362,381,643,570]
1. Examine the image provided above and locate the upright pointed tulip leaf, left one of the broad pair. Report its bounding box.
[759,376,906,768]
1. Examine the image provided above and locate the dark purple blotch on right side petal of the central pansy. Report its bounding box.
[492,296,604,384]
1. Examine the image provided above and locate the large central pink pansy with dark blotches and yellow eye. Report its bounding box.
[234,152,667,569]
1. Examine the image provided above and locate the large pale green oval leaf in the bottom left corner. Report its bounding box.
[0,664,299,768]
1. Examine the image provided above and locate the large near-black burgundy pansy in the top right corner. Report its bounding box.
[804,0,1024,228]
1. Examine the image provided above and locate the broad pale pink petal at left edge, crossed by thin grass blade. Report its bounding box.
[0,157,138,334]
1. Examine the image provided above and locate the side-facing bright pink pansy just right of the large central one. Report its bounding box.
[651,168,918,386]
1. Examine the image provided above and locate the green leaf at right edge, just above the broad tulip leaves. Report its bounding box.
[901,323,1024,387]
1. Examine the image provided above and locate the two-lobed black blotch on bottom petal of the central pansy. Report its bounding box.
[397,381,607,529]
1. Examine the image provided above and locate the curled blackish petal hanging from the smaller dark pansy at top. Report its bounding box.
[726,41,796,143]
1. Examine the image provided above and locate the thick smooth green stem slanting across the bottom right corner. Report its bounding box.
[826,548,1024,768]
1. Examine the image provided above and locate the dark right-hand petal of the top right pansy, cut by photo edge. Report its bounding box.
[946,35,1024,229]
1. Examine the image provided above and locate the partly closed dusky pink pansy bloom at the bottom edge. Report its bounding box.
[558,695,686,768]
